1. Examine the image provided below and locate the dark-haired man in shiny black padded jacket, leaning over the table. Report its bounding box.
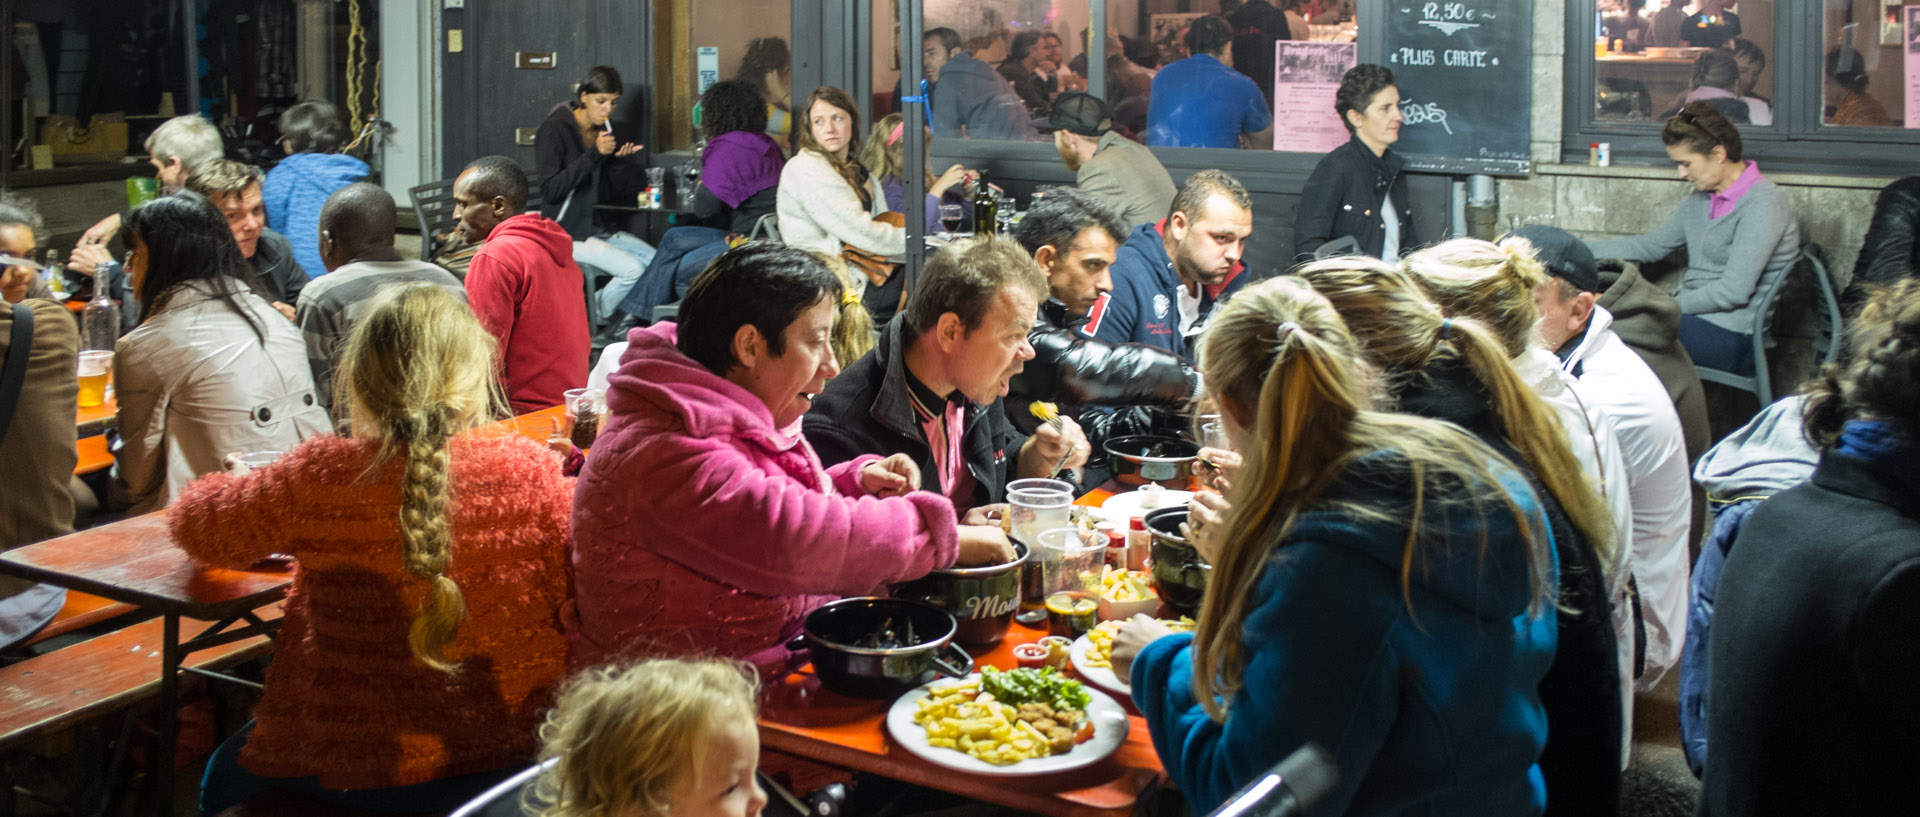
[1000,190,1200,460]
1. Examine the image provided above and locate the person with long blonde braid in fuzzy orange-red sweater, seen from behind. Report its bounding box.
[167,284,572,815]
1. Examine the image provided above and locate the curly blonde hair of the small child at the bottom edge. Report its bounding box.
[530,658,758,817]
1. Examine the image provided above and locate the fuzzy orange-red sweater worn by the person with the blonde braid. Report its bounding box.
[167,430,572,788]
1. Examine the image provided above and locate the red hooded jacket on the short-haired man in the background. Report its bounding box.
[467,213,591,414]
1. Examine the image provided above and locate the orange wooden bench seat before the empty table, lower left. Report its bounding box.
[0,604,280,750]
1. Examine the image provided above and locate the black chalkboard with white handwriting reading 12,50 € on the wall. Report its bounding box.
[1380,0,1534,175]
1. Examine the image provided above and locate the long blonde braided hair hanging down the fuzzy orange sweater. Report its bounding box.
[334,284,499,671]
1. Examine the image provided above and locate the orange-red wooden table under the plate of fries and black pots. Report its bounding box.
[760,485,1165,817]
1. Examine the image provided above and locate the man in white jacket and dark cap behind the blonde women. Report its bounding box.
[1501,226,1693,692]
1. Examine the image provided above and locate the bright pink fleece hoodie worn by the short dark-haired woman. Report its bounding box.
[566,322,958,675]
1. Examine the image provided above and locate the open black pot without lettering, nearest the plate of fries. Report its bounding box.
[793,596,973,698]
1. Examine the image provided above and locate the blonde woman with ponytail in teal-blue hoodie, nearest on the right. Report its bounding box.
[1114,278,1555,815]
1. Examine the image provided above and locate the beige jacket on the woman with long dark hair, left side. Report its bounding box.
[113,280,332,514]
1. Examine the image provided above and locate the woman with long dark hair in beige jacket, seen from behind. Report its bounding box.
[113,192,332,514]
